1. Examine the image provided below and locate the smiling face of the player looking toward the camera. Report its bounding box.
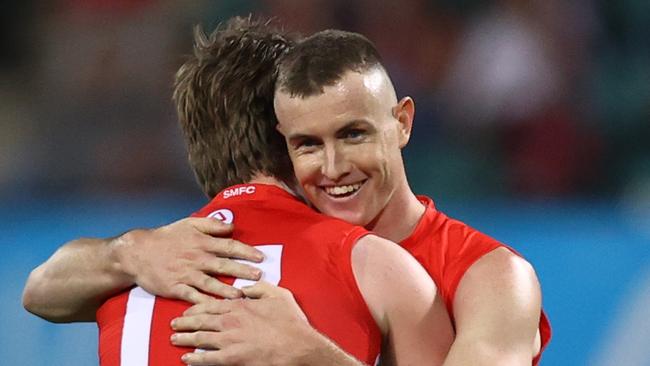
[275,67,413,228]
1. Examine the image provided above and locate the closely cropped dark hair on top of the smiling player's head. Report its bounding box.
[276,29,383,98]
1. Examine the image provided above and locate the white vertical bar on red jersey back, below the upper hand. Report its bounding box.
[120,287,156,366]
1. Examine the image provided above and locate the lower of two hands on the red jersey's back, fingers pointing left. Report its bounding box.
[172,282,322,366]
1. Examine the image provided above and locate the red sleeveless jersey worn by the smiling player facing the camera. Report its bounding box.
[401,196,551,365]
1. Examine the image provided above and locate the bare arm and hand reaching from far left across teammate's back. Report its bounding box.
[23,218,262,322]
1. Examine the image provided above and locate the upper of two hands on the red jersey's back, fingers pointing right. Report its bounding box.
[115,218,264,304]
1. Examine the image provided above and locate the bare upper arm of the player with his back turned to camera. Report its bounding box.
[352,236,454,365]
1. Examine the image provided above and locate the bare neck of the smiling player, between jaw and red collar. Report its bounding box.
[366,177,425,243]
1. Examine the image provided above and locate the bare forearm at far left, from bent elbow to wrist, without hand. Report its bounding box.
[23,235,133,322]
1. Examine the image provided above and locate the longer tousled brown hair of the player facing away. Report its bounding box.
[173,17,295,197]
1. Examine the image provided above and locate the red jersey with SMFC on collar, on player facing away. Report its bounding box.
[98,184,381,366]
